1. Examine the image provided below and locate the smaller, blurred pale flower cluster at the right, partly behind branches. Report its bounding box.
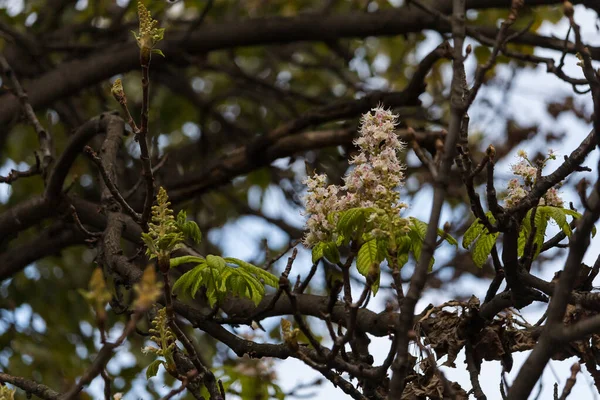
[504,150,564,207]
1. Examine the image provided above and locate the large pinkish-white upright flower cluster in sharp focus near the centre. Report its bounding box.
[304,107,407,247]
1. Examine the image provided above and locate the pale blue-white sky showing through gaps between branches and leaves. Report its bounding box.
[0,0,600,400]
